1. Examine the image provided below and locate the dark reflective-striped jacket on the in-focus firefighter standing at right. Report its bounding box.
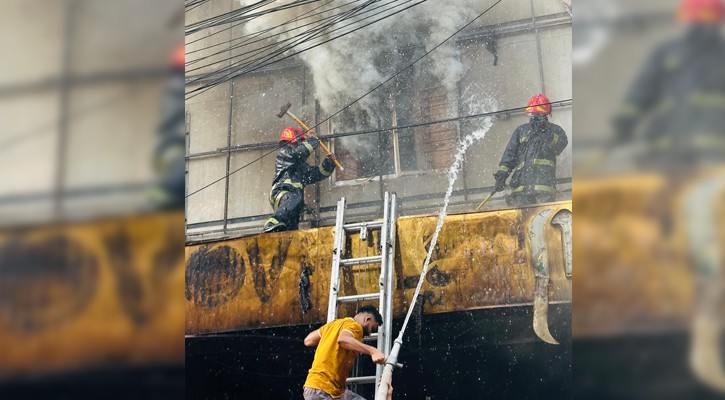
[496,115,568,194]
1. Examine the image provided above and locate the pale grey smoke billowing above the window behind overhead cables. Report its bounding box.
[240,0,480,125]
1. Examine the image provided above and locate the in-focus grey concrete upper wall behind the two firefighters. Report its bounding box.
[187,0,573,239]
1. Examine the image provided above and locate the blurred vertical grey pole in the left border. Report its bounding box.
[53,0,76,220]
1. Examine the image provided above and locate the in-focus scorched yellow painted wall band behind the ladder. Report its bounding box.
[186,202,571,334]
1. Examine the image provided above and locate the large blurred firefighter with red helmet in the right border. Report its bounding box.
[614,0,725,168]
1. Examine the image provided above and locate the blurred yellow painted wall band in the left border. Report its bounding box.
[0,212,184,376]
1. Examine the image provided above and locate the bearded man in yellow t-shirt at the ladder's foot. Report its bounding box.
[304,306,385,400]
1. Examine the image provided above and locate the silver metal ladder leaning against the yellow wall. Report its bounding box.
[327,192,396,385]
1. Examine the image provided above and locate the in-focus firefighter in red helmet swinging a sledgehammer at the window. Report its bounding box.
[262,127,335,233]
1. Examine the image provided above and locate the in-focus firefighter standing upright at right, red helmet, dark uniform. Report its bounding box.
[493,94,568,207]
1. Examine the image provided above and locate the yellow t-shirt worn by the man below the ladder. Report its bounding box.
[305,318,363,398]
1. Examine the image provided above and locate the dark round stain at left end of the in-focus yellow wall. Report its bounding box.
[185,245,246,308]
